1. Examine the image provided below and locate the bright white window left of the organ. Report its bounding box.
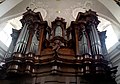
[0,16,22,47]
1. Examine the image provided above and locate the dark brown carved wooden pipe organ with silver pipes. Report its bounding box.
[3,9,116,84]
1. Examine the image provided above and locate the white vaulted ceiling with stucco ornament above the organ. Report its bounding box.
[0,0,120,25]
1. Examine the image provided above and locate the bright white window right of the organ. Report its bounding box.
[98,17,118,49]
